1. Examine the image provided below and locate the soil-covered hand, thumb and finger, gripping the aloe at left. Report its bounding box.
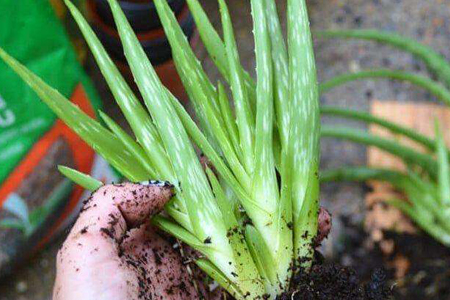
[53,182,199,300]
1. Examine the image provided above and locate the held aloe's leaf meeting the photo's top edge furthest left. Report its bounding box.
[65,0,173,180]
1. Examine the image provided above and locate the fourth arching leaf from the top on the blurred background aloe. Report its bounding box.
[321,126,438,177]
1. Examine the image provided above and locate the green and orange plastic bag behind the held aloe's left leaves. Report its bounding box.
[0,0,115,276]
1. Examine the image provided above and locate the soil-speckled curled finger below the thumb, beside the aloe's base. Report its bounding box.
[122,225,200,300]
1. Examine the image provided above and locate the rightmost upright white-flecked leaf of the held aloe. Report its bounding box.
[288,0,320,257]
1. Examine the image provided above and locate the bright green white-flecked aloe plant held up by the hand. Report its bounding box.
[0,0,320,299]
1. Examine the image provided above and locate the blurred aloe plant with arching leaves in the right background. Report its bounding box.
[317,30,450,247]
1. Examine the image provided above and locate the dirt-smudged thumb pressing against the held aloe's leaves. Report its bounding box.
[54,183,172,300]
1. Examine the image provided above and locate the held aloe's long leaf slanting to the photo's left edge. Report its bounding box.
[0,48,148,181]
